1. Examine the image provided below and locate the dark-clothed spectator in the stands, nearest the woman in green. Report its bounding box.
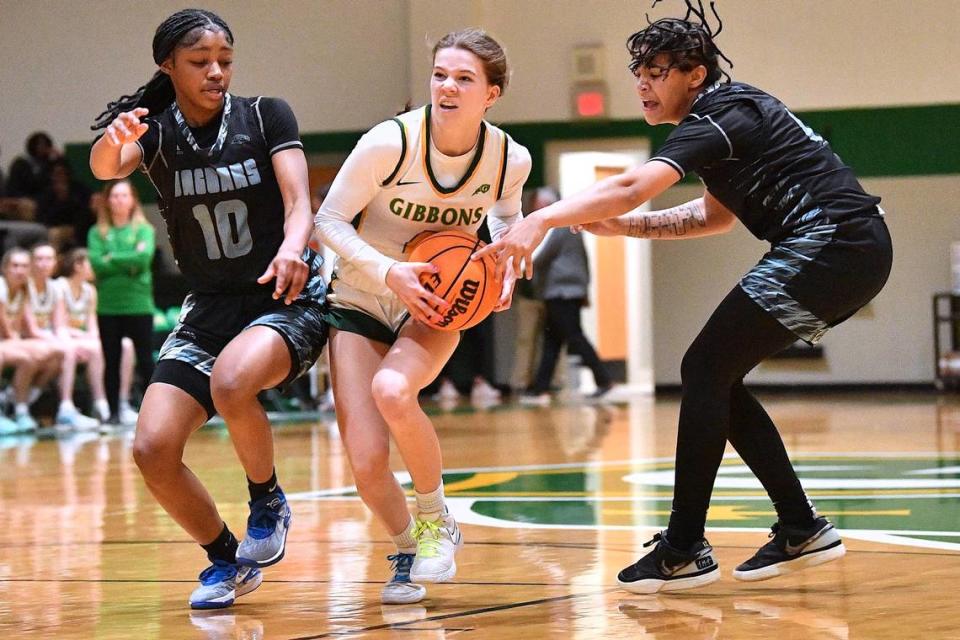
[37,160,93,252]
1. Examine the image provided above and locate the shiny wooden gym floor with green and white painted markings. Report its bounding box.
[0,393,960,640]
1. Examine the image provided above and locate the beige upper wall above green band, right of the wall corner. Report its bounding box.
[410,0,960,122]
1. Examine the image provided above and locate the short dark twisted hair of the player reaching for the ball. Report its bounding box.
[627,0,733,85]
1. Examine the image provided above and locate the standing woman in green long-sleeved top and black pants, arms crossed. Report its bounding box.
[87,180,157,423]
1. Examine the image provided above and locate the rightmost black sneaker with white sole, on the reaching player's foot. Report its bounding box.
[733,518,847,581]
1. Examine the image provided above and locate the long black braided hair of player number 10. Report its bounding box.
[90,9,233,131]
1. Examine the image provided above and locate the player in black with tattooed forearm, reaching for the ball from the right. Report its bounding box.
[478,1,892,593]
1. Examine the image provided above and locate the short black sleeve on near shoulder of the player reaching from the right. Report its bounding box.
[650,101,763,177]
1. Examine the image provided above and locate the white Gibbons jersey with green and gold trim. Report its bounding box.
[332,105,516,295]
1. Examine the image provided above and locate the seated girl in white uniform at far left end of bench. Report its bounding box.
[0,247,60,431]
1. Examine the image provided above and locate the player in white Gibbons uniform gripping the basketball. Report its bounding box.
[316,29,530,603]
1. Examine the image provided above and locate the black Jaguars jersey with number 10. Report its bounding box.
[138,95,303,293]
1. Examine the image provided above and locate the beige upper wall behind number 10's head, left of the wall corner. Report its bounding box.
[0,0,408,168]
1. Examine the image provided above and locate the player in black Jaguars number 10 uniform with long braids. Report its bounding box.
[90,9,326,608]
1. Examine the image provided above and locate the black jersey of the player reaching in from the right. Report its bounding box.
[650,82,880,242]
